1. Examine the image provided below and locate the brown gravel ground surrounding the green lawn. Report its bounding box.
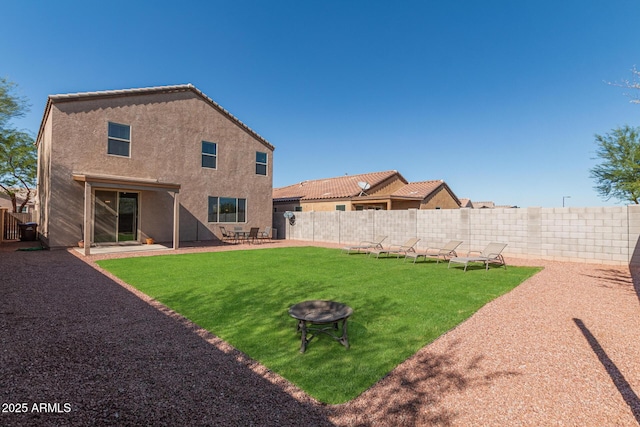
[0,242,640,426]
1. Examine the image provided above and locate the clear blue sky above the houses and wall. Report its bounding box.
[0,0,640,207]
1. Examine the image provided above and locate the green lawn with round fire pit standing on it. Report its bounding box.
[98,247,539,404]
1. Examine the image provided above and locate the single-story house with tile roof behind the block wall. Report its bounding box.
[273,170,460,212]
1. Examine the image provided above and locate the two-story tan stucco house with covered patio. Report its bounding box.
[36,84,274,253]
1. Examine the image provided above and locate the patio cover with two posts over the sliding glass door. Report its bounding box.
[72,173,181,255]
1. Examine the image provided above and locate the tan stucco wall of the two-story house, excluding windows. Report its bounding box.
[39,91,273,247]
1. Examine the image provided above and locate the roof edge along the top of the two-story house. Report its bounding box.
[36,83,275,150]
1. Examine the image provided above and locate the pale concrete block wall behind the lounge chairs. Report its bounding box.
[274,205,640,266]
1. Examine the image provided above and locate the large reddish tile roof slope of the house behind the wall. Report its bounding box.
[273,170,406,200]
